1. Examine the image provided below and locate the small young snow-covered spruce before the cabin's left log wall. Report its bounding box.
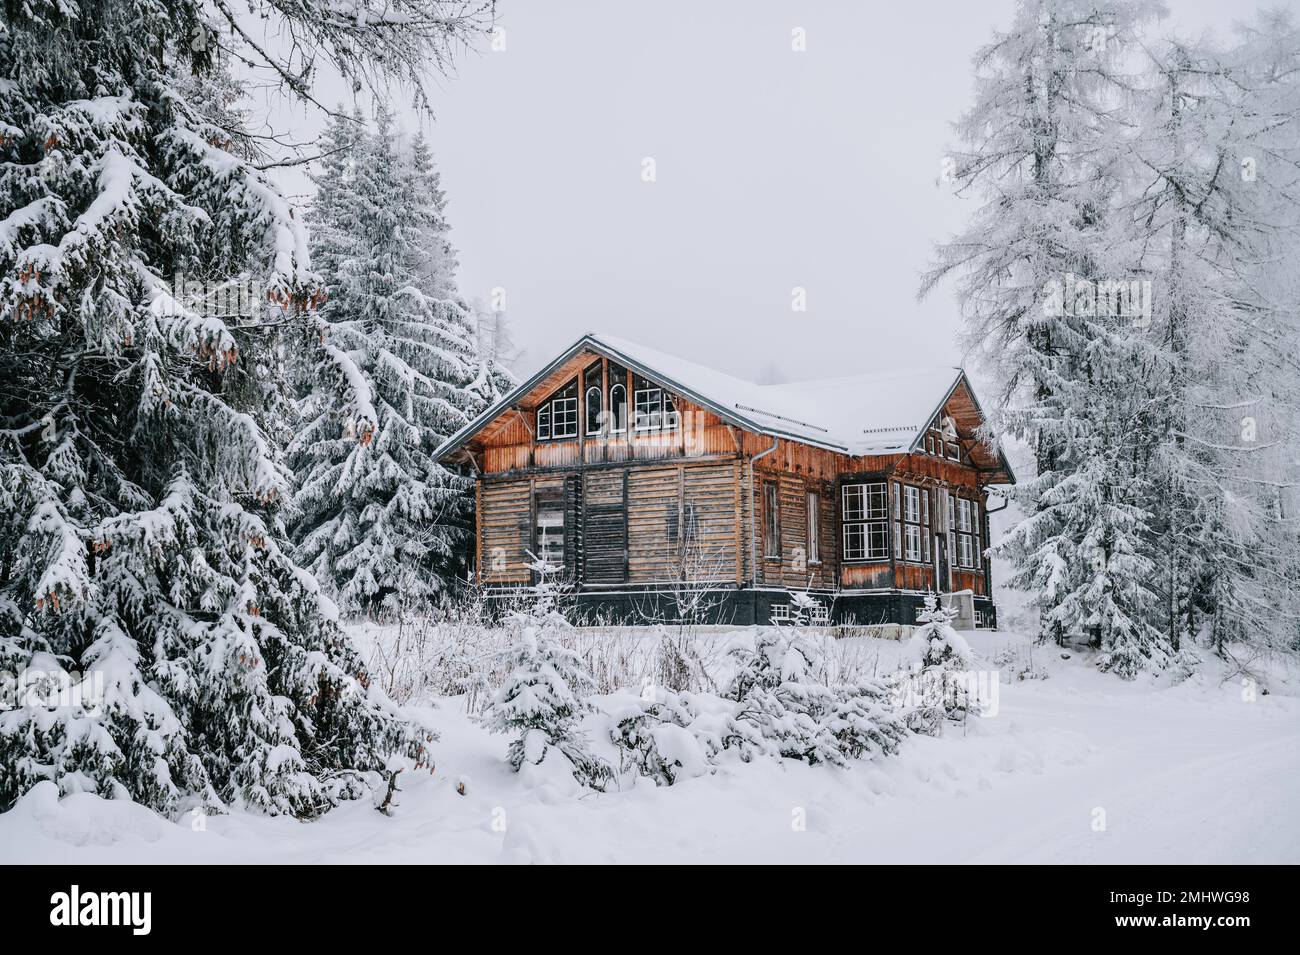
[485,559,614,789]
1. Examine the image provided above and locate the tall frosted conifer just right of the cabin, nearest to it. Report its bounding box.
[923,0,1167,667]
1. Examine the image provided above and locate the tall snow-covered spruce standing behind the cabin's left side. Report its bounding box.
[289,112,490,613]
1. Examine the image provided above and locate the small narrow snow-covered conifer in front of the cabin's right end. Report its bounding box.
[900,594,979,735]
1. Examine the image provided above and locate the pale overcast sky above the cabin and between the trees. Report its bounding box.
[256,0,1275,379]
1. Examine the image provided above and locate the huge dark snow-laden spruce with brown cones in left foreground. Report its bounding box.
[0,0,488,816]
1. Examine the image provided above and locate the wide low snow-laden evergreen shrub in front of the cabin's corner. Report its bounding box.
[723,630,906,765]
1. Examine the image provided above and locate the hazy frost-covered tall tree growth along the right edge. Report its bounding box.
[1125,12,1300,657]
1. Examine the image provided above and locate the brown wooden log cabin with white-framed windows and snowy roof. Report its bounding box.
[437,334,1014,626]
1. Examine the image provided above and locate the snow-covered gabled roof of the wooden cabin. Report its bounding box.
[438,333,1008,467]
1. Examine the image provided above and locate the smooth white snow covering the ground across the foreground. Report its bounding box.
[0,633,1300,864]
